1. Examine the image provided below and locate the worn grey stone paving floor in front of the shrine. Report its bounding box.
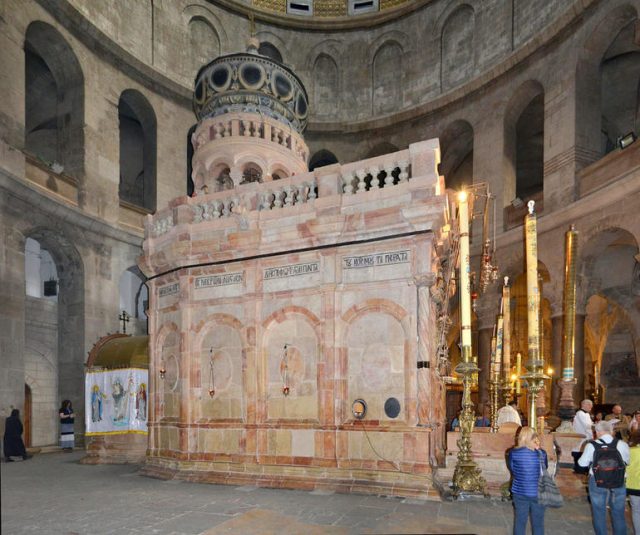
[0,452,616,535]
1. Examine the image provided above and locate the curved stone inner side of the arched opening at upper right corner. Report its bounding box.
[575,4,638,166]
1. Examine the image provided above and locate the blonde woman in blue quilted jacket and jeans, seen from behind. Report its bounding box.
[508,427,547,535]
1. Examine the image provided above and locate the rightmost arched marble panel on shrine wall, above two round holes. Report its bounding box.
[336,298,417,422]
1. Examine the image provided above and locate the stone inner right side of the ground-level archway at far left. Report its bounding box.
[24,227,85,433]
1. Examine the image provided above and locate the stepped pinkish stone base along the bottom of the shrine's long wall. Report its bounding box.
[140,458,440,500]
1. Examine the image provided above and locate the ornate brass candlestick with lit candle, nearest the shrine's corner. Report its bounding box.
[453,191,487,496]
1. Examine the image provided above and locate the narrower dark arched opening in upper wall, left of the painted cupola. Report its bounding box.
[118,89,157,212]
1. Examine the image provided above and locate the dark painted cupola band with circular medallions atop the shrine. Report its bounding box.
[193,52,309,133]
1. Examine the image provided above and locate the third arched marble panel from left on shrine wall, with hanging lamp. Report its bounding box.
[258,305,324,421]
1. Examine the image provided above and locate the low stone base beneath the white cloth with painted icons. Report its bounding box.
[80,433,147,464]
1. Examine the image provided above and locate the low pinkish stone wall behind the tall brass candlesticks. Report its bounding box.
[434,427,557,497]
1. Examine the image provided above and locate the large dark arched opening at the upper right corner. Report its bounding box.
[575,5,640,170]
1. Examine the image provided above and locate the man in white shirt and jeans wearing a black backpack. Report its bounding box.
[578,421,629,535]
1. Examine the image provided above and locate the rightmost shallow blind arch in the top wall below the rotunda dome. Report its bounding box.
[440,4,475,91]
